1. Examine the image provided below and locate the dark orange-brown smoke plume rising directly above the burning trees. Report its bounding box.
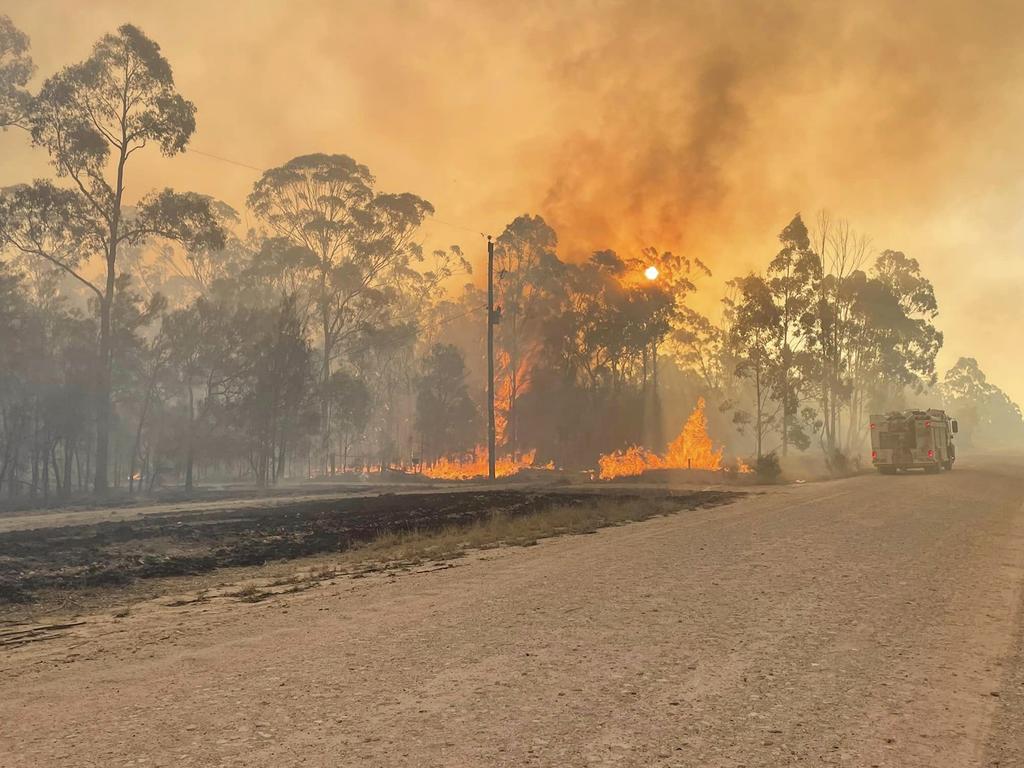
[541,51,748,256]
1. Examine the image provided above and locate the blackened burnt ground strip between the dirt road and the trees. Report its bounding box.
[0,489,737,604]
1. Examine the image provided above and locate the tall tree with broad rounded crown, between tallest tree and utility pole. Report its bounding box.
[248,154,433,471]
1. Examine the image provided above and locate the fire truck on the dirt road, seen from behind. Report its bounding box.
[871,409,957,475]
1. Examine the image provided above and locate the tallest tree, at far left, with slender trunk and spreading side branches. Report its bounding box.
[0,25,223,494]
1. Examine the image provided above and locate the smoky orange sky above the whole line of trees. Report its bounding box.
[0,0,1024,401]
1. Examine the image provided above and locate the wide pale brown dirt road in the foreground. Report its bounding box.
[0,460,1024,768]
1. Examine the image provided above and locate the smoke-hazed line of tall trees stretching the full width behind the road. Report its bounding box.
[0,16,1024,497]
